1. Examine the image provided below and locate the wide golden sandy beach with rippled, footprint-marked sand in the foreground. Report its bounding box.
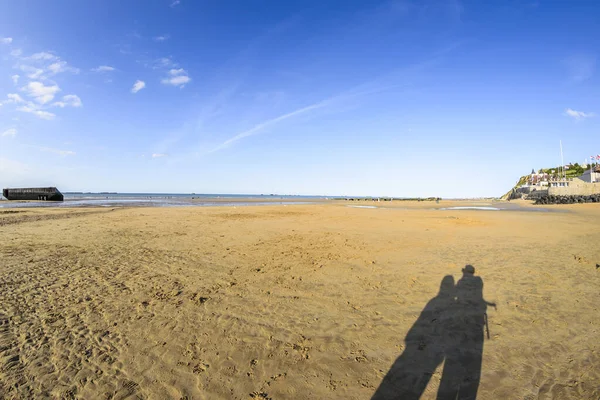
[0,201,600,400]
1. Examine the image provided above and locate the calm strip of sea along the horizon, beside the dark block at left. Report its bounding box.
[0,193,327,208]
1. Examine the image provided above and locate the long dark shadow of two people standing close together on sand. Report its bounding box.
[372,265,496,400]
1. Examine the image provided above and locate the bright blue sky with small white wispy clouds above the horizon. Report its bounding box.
[0,0,600,197]
